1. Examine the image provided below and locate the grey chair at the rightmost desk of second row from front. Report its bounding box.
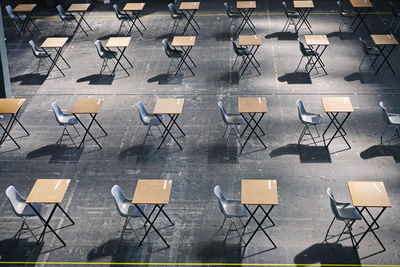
[296,99,322,146]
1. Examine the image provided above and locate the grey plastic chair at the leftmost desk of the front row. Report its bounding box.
[6,185,45,241]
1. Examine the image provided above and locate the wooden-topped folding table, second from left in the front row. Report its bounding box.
[132,179,174,247]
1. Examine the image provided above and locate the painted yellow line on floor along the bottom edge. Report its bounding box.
[0,261,400,267]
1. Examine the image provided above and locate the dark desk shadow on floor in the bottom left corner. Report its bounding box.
[0,239,43,263]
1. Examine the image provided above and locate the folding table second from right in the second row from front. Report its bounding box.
[238,97,268,153]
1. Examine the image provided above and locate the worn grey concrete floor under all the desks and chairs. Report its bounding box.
[0,1,400,266]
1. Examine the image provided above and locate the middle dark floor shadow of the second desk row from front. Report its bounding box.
[207,144,240,164]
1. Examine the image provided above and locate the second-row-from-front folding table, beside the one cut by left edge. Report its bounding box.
[71,98,108,149]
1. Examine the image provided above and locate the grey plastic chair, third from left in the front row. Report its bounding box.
[214,185,250,245]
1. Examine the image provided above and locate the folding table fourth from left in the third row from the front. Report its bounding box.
[239,35,262,77]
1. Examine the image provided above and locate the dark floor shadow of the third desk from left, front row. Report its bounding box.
[193,240,243,264]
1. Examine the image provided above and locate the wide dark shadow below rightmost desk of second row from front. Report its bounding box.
[269,144,332,163]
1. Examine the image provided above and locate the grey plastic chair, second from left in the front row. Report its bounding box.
[111,185,147,240]
